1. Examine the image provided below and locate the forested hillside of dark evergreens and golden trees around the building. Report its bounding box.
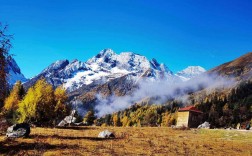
[95,79,252,128]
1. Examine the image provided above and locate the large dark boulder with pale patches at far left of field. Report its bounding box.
[6,123,31,138]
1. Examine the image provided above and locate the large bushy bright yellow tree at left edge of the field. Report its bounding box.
[18,79,56,125]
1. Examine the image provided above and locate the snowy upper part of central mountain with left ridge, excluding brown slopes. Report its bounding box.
[26,49,174,92]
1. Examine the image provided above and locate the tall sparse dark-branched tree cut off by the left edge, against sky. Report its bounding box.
[0,22,12,108]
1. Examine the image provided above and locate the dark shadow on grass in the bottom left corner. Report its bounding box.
[0,139,78,155]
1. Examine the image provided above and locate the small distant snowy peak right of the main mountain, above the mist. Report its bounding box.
[175,66,206,81]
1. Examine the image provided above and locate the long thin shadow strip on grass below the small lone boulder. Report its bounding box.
[29,134,121,141]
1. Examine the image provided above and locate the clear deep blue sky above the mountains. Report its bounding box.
[0,0,252,78]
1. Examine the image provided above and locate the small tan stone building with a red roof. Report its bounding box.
[176,106,203,128]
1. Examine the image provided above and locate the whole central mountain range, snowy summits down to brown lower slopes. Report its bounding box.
[24,49,209,116]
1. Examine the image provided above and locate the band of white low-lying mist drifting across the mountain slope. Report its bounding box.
[95,74,235,117]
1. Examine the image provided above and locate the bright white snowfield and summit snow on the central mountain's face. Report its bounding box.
[64,49,175,91]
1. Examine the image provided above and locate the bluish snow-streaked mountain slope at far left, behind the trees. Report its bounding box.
[5,56,27,85]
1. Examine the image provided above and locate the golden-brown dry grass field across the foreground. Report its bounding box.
[0,127,252,156]
